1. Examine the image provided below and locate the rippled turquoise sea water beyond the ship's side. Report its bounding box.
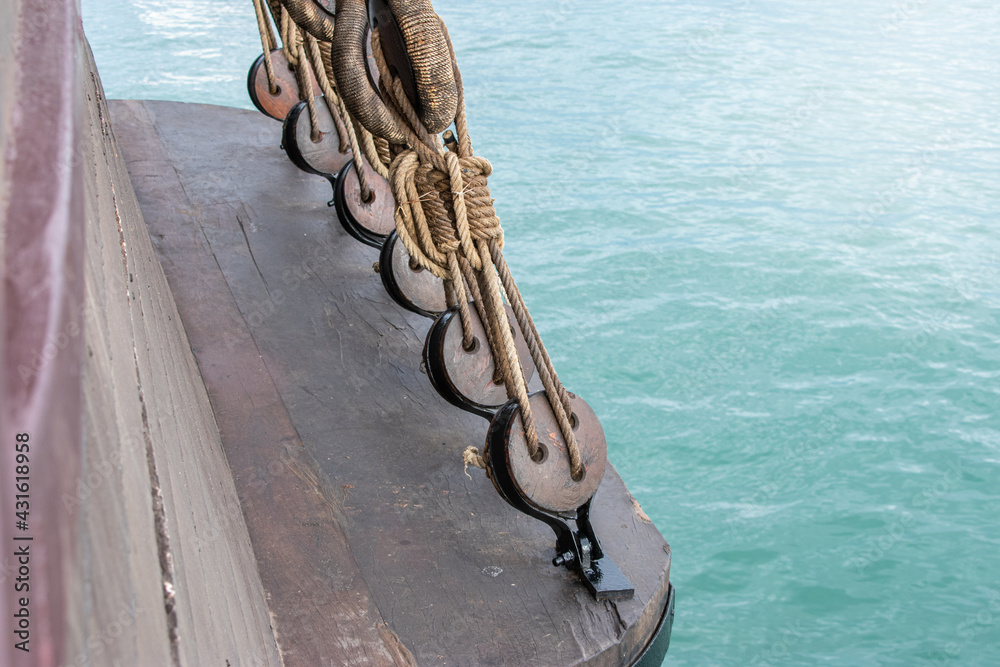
[83,0,1000,666]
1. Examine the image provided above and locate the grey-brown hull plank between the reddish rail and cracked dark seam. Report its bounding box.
[74,39,172,665]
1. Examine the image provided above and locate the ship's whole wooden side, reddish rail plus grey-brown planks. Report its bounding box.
[0,14,281,667]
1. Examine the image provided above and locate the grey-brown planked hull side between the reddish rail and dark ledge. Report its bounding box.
[71,45,281,666]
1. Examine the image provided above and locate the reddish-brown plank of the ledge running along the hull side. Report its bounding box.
[114,102,407,666]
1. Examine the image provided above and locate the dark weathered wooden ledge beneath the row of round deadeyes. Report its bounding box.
[111,96,670,666]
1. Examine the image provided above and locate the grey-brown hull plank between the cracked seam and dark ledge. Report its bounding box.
[79,43,280,665]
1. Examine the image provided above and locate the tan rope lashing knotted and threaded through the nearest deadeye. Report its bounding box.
[358,15,583,479]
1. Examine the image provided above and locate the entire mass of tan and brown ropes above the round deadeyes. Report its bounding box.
[270,0,583,480]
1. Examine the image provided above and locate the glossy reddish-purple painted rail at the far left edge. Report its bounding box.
[0,0,84,666]
